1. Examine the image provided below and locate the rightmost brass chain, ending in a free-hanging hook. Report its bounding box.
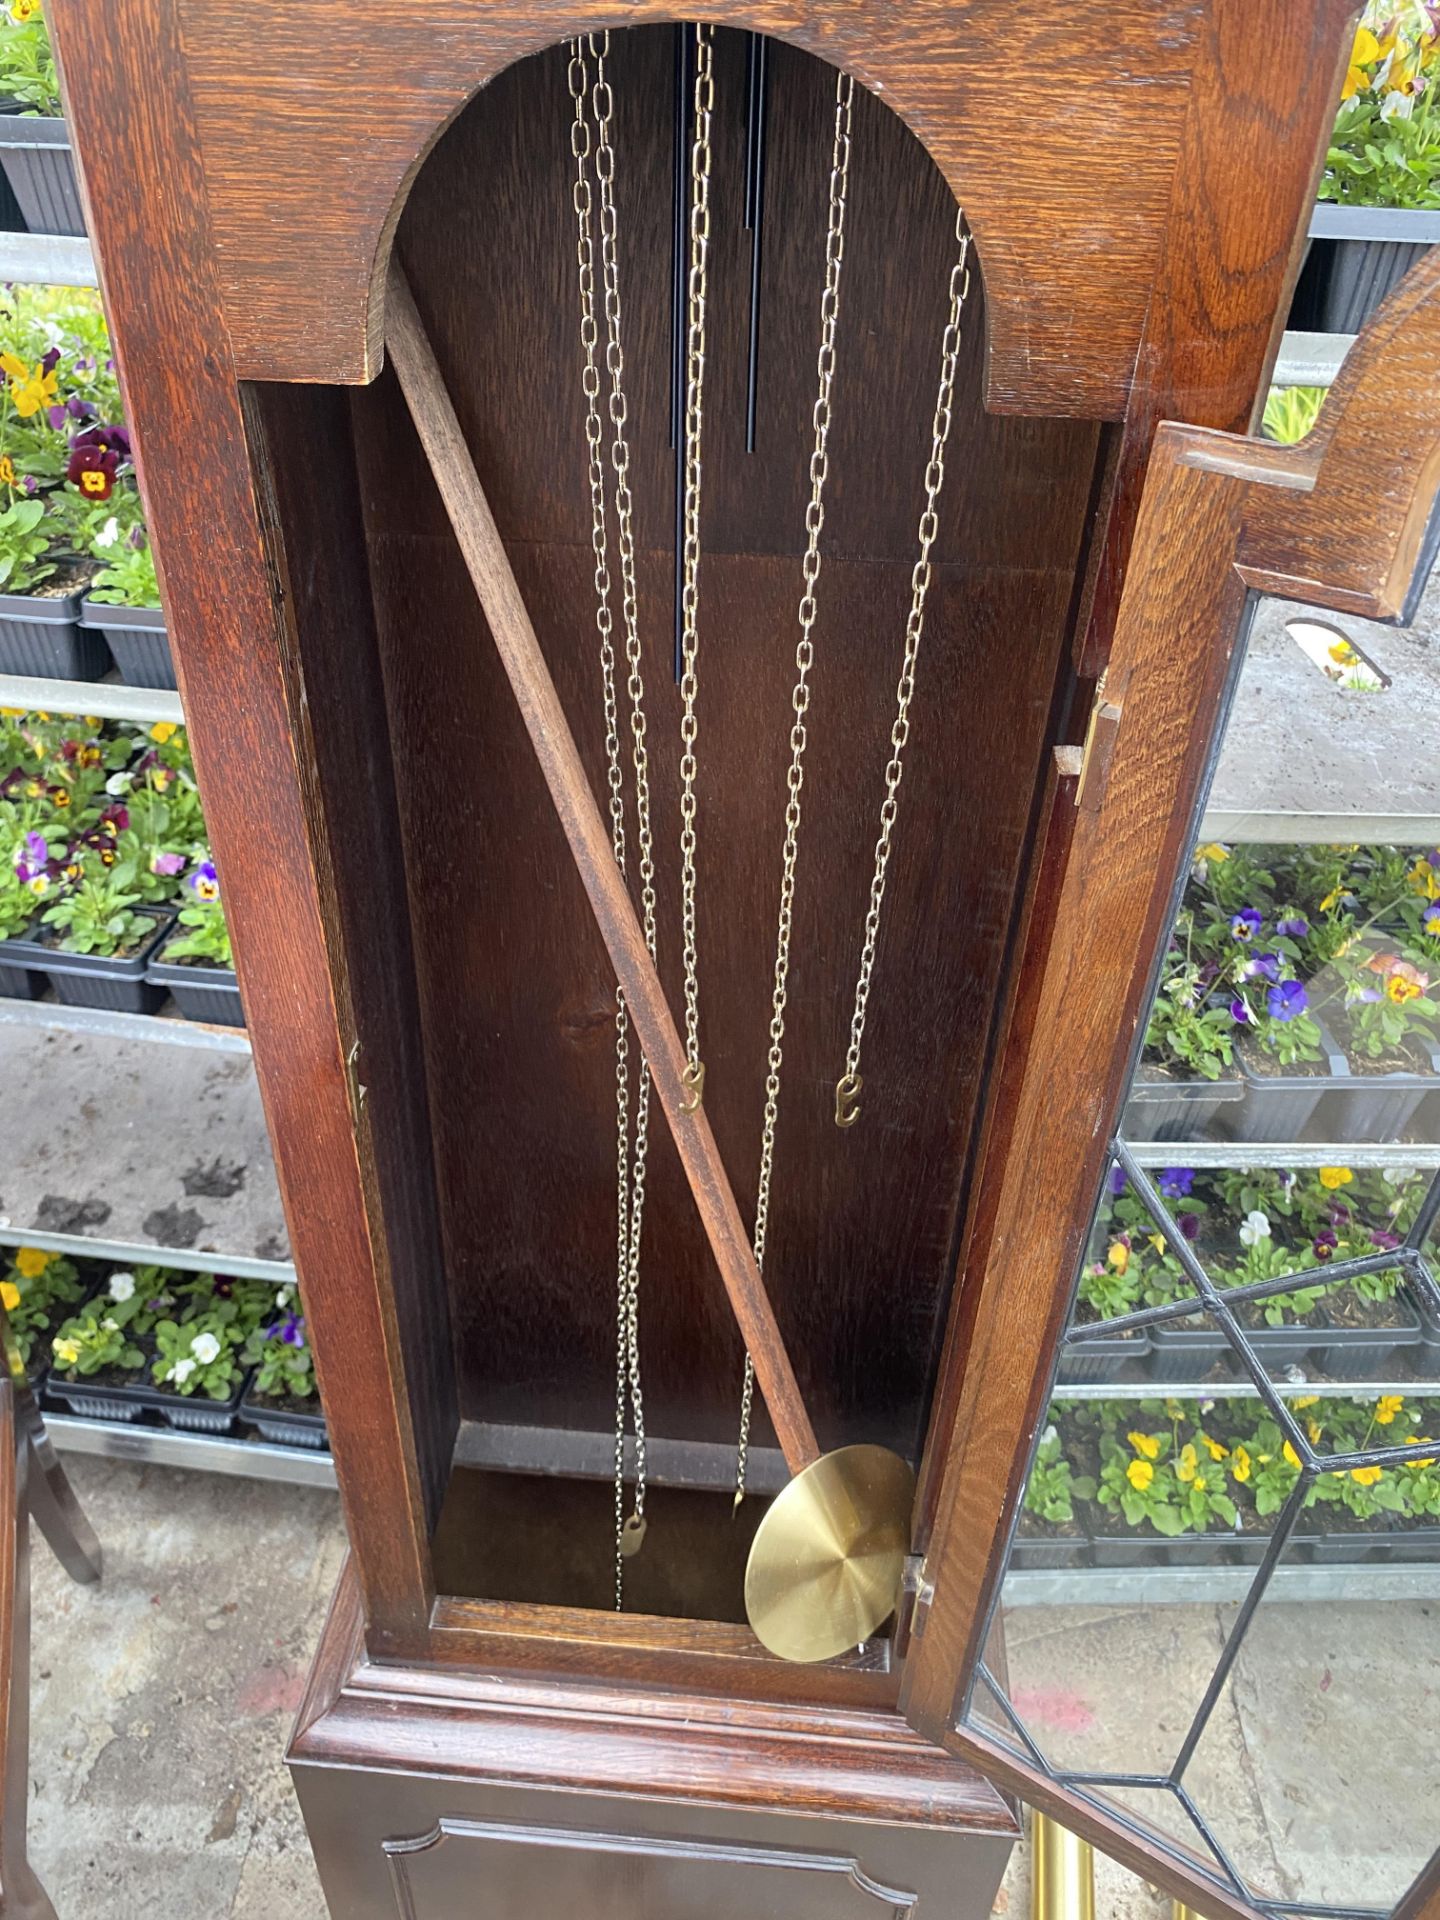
[835,207,970,1127]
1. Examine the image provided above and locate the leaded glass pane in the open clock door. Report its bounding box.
[972,549,1440,1916]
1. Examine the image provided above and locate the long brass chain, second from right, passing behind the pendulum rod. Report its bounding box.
[735,73,854,1505]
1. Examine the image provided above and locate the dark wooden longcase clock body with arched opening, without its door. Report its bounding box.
[52,0,1367,1920]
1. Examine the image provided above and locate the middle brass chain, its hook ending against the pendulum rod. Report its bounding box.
[680,25,714,1114]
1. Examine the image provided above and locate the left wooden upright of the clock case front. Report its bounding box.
[48,0,432,1649]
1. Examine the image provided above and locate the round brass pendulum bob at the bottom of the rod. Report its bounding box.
[745,1446,916,1661]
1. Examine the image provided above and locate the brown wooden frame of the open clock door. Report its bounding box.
[902,253,1440,1920]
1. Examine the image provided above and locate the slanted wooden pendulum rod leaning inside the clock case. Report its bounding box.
[386,261,820,1473]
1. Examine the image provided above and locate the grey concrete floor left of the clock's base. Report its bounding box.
[31,1459,344,1920]
